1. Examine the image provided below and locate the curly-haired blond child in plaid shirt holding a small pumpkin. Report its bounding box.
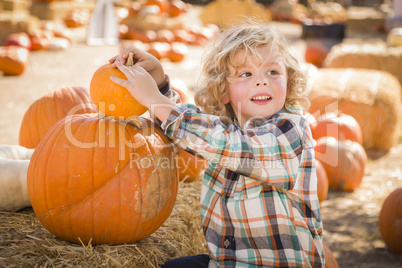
[111,23,324,267]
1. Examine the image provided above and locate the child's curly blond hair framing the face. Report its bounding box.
[195,22,309,120]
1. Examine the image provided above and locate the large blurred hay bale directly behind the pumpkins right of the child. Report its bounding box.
[309,68,401,152]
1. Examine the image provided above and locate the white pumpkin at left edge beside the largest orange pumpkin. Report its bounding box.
[0,144,34,211]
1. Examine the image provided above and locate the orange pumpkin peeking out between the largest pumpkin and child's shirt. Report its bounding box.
[176,150,207,181]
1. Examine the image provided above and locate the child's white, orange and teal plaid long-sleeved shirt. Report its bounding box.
[161,89,324,267]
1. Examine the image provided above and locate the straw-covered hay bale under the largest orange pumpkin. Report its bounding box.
[0,178,208,267]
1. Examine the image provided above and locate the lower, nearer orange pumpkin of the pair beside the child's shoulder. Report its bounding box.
[314,137,367,191]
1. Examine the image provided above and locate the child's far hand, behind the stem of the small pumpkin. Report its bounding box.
[109,46,165,85]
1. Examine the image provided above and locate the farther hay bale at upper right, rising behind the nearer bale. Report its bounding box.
[324,42,402,88]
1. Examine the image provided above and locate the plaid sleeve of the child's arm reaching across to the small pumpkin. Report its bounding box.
[161,104,313,190]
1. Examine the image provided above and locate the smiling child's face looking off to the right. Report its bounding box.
[221,45,287,125]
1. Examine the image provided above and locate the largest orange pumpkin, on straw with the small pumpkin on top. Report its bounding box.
[27,114,178,244]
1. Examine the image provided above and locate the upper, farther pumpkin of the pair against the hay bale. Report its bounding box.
[311,113,363,144]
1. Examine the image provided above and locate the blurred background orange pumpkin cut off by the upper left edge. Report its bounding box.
[0,46,29,75]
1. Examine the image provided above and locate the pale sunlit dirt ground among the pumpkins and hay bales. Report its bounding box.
[0,22,402,267]
